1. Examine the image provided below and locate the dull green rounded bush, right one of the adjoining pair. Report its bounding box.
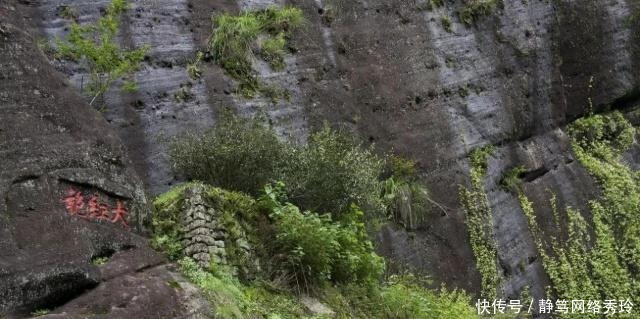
[281,126,384,217]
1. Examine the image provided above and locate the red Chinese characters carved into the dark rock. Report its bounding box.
[62,188,129,228]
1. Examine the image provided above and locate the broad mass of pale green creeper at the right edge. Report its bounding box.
[519,112,640,318]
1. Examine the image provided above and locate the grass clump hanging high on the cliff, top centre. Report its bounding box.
[209,7,304,98]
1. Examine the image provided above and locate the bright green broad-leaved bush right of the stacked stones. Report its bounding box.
[260,183,384,288]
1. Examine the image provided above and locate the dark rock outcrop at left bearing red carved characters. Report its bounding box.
[0,0,206,318]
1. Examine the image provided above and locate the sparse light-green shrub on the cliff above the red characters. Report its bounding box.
[56,0,148,104]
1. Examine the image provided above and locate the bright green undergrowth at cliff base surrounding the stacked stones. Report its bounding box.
[153,183,477,319]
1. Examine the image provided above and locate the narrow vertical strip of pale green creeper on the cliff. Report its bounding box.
[460,145,500,299]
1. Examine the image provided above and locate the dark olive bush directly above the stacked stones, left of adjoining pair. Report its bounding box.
[169,113,293,195]
